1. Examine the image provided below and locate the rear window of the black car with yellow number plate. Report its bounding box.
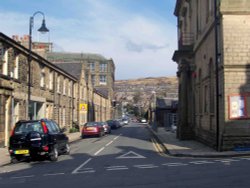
[14,122,43,134]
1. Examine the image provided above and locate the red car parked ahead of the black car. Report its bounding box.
[82,122,105,138]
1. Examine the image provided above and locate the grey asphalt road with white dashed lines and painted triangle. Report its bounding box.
[0,124,250,188]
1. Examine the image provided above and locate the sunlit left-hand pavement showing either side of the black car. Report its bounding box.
[0,132,81,167]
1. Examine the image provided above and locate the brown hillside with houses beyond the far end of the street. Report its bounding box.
[115,77,178,114]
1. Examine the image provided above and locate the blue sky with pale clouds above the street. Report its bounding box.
[0,0,177,80]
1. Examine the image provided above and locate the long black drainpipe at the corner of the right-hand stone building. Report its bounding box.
[214,0,221,151]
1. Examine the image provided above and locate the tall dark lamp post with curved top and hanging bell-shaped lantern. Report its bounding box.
[27,11,49,120]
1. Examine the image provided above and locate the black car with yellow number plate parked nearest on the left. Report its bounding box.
[9,119,70,163]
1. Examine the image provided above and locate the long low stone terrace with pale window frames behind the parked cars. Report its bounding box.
[0,33,111,146]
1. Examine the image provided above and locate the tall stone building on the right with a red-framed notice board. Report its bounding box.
[173,0,250,151]
